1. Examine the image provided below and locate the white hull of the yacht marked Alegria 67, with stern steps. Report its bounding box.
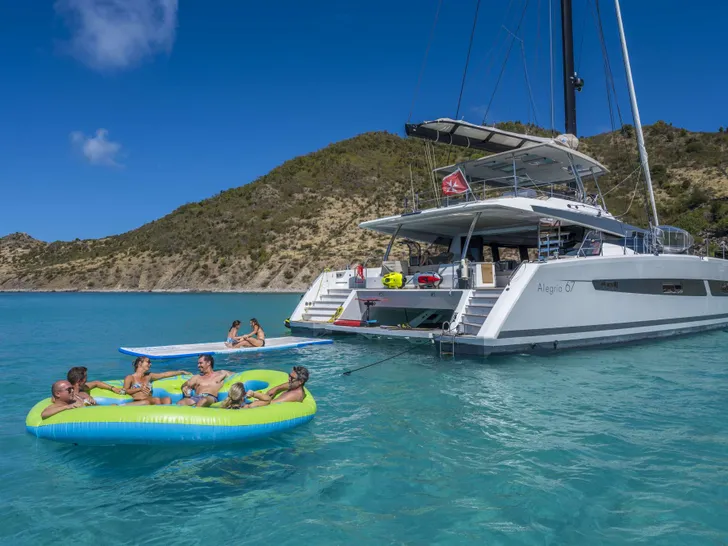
[291,255,728,355]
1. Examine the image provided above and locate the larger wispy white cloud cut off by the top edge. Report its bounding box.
[55,0,178,70]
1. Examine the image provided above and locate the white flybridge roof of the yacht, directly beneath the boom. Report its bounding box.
[435,141,609,187]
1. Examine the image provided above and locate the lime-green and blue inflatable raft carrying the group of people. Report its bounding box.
[25,370,316,445]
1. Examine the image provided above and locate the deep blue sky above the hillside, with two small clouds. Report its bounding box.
[0,0,728,241]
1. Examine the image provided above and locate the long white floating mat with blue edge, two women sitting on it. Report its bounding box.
[119,337,333,359]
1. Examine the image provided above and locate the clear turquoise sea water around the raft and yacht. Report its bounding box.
[0,294,728,545]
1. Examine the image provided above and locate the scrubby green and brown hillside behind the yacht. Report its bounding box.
[0,122,728,290]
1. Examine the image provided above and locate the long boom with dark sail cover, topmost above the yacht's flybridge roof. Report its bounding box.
[404,118,552,153]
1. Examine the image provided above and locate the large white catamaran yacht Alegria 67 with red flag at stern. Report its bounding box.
[290,0,728,355]
